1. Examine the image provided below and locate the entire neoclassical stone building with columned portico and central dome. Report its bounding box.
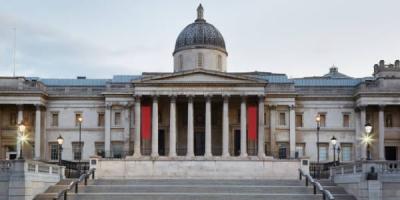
[0,5,400,162]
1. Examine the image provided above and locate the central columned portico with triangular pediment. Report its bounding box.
[133,70,266,159]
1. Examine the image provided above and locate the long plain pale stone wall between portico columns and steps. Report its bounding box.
[95,158,300,179]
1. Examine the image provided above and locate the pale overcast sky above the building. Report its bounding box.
[0,0,400,78]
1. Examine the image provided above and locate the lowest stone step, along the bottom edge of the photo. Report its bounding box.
[68,193,322,200]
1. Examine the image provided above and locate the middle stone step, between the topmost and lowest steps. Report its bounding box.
[83,184,310,194]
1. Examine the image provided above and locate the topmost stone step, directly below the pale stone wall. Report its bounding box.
[89,179,304,186]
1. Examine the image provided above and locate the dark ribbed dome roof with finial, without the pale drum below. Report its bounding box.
[173,5,227,54]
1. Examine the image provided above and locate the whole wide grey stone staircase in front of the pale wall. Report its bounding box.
[35,179,355,200]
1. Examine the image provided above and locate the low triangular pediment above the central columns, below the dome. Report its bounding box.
[135,69,265,84]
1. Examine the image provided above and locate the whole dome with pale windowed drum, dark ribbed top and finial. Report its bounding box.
[173,4,228,72]
